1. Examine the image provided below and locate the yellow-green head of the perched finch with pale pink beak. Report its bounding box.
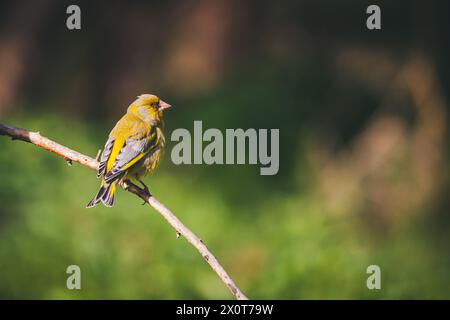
[128,94,171,121]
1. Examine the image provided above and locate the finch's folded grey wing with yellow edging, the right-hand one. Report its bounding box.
[104,122,158,182]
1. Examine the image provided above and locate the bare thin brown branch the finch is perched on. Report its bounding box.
[0,124,247,300]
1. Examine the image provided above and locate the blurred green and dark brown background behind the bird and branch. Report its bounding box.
[0,0,450,299]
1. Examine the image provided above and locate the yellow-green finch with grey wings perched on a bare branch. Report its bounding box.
[86,94,171,208]
